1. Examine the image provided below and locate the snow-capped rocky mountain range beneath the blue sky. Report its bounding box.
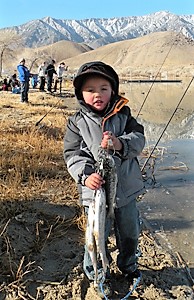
[1,11,194,48]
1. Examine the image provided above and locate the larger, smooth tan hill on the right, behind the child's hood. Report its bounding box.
[63,32,194,76]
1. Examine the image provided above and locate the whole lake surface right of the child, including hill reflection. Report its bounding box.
[122,78,194,276]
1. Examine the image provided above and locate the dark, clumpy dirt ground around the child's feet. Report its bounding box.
[0,201,193,300]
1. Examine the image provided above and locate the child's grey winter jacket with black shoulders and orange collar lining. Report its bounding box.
[64,96,145,207]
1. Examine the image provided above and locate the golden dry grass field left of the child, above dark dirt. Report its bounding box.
[0,88,75,204]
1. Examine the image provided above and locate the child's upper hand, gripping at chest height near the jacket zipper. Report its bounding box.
[101,131,123,151]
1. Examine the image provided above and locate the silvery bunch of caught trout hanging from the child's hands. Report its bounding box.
[86,147,117,285]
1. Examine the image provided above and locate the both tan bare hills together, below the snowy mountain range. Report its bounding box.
[3,32,194,78]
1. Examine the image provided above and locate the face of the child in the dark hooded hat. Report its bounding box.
[82,76,112,111]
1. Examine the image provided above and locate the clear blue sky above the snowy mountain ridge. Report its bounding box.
[0,0,194,28]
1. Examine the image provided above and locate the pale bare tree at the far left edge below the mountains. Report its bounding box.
[0,29,22,77]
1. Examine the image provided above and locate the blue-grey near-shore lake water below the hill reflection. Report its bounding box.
[139,139,194,277]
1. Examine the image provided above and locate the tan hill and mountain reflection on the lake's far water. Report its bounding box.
[120,78,194,141]
